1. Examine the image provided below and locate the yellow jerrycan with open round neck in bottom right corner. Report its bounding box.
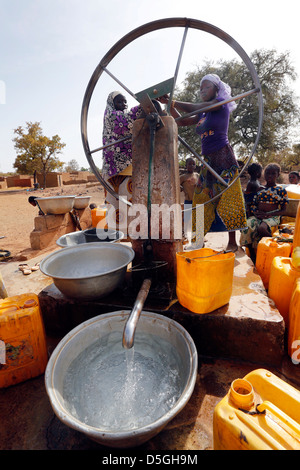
[213,369,300,450]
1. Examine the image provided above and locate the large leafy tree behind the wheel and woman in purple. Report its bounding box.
[176,49,300,166]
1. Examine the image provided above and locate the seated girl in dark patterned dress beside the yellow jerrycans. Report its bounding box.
[240,163,288,263]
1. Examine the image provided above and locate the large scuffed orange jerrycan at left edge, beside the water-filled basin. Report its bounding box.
[0,294,48,388]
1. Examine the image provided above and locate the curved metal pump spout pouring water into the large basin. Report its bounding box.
[122,279,151,349]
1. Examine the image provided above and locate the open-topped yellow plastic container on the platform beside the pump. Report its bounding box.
[176,248,235,313]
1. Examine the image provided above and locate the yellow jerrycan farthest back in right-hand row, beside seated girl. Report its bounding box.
[255,237,292,289]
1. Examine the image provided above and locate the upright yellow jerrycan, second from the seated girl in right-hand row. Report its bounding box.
[268,256,300,326]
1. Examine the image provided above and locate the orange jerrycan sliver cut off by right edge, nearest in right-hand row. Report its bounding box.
[288,277,300,364]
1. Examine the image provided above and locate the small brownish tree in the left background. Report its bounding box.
[13,122,66,187]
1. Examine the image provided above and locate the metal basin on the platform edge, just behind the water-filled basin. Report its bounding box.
[40,242,134,300]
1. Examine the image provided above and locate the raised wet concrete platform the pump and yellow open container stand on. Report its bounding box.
[39,237,285,365]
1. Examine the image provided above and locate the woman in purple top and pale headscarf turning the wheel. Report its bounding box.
[159,74,247,251]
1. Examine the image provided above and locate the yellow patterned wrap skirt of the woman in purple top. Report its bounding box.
[193,145,247,239]
